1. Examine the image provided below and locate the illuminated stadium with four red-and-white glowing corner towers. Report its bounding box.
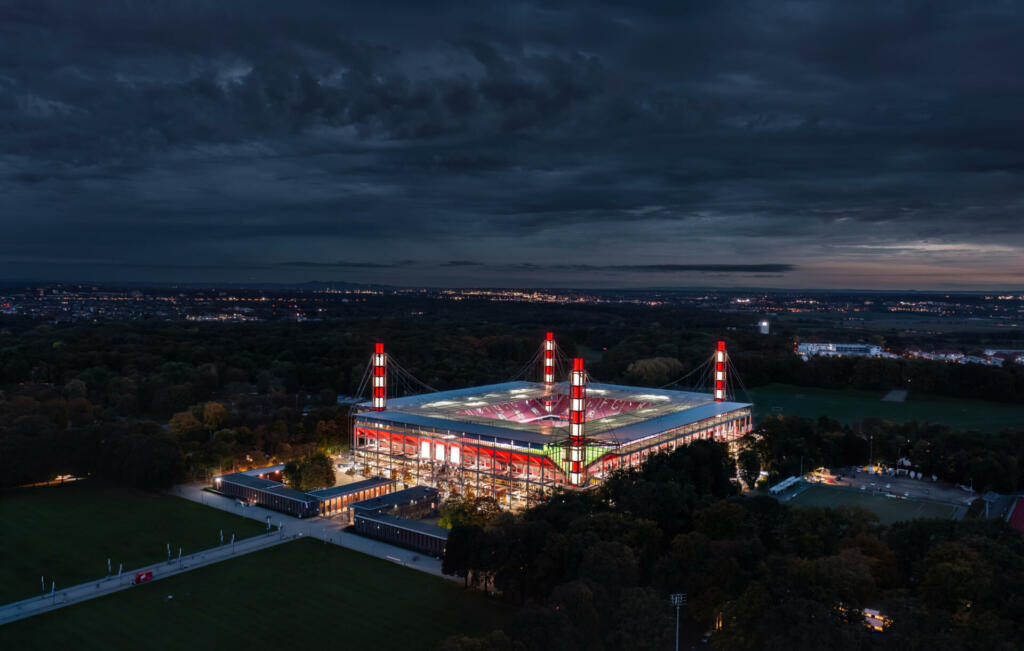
[352,334,752,509]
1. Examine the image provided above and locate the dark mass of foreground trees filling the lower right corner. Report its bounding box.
[443,441,1024,651]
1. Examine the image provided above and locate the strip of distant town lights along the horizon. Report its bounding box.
[0,284,1024,330]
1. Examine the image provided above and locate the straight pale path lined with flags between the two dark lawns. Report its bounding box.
[0,531,299,624]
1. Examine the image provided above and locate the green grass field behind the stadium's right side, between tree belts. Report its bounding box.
[739,384,1024,432]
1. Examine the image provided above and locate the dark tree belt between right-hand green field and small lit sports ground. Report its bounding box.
[749,416,1024,492]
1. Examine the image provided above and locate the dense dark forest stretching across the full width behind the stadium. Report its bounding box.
[0,299,1024,488]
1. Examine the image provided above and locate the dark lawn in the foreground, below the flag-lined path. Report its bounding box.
[0,539,508,651]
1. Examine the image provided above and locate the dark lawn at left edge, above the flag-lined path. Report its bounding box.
[0,480,264,601]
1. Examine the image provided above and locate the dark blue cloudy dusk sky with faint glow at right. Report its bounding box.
[0,0,1024,289]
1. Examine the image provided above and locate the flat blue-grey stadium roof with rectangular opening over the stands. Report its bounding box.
[357,382,751,445]
